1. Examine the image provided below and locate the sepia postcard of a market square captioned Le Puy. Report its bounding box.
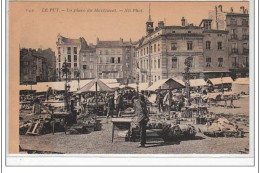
[7,1,255,165]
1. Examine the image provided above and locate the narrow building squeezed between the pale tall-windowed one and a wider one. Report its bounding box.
[79,42,97,79]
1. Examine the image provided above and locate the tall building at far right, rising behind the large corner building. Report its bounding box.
[209,5,249,78]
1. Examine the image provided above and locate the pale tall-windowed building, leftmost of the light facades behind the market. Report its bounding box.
[56,34,83,79]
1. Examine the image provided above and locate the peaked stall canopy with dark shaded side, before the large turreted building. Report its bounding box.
[147,78,185,91]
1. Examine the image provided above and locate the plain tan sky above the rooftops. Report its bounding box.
[9,2,250,52]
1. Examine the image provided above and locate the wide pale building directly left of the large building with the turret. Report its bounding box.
[96,38,133,83]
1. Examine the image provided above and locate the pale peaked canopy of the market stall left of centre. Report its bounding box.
[76,79,113,94]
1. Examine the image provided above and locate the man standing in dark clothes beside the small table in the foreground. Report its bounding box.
[134,94,149,147]
